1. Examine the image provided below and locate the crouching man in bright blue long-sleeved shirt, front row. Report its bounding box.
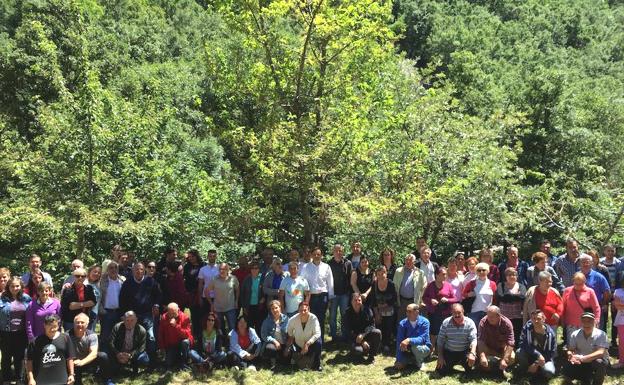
[394,303,431,370]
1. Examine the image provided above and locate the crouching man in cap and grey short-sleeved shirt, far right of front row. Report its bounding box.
[563,311,609,385]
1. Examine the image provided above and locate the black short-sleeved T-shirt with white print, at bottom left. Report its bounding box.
[27,333,76,385]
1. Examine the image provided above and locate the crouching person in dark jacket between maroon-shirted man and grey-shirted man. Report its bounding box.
[516,309,557,379]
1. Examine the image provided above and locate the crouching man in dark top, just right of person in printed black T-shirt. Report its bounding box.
[69,313,114,385]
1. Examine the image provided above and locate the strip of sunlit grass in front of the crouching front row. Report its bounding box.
[98,345,624,385]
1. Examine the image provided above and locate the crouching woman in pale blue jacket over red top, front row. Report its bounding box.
[228,315,262,370]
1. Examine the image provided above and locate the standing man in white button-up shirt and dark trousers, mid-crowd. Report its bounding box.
[301,247,334,344]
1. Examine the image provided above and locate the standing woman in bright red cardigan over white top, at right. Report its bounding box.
[522,271,563,335]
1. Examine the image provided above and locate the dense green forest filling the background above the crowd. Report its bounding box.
[0,0,624,270]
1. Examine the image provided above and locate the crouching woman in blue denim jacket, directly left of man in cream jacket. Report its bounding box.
[260,300,290,367]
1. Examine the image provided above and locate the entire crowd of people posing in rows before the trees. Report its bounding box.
[0,239,624,385]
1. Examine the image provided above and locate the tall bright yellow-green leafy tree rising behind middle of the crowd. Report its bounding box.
[208,0,394,244]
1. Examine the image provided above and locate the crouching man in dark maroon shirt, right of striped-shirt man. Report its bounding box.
[477,305,515,374]
